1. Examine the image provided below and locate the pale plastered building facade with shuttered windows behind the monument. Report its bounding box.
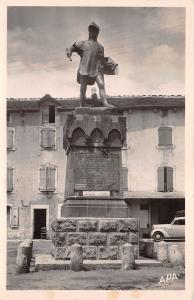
[7,95,185,239]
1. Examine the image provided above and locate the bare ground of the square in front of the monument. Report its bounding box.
[7,241,185,290]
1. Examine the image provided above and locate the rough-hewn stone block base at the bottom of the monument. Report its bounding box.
[51,218,139,260]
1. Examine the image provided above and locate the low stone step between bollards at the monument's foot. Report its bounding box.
[35,254,163,271]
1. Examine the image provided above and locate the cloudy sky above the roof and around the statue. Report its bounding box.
[7,7,185,98]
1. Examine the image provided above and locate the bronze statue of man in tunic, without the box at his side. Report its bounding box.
[66,22,114,108]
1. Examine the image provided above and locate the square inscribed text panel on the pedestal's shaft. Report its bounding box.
[74,153,119,191]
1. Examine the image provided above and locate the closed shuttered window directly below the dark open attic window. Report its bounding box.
[40,127,56,148]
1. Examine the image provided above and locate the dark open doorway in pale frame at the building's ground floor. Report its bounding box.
[33,209,46,239]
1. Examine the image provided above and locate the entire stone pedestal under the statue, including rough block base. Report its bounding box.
[51,107,139,260]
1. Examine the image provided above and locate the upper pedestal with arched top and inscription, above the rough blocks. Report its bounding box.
[61,107,128,218]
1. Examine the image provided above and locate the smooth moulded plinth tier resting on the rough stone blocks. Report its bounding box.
[61,196,128,218]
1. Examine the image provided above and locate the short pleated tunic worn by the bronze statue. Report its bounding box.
[73,40,104,85]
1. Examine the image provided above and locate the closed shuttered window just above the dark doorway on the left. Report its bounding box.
[39,166,56,192]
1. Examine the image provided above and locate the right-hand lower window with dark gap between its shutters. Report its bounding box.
[158,167,173,192]
